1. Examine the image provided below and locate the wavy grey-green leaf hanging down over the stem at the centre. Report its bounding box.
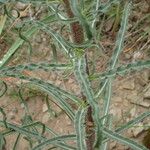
[74,55,101,146]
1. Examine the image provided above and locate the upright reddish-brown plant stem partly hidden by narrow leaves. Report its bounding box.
[63,0,95,150]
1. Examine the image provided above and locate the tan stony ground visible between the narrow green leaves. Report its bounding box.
[0,1,150,150]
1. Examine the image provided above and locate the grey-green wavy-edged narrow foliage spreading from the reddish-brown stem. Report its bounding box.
[0,0,150,150]
